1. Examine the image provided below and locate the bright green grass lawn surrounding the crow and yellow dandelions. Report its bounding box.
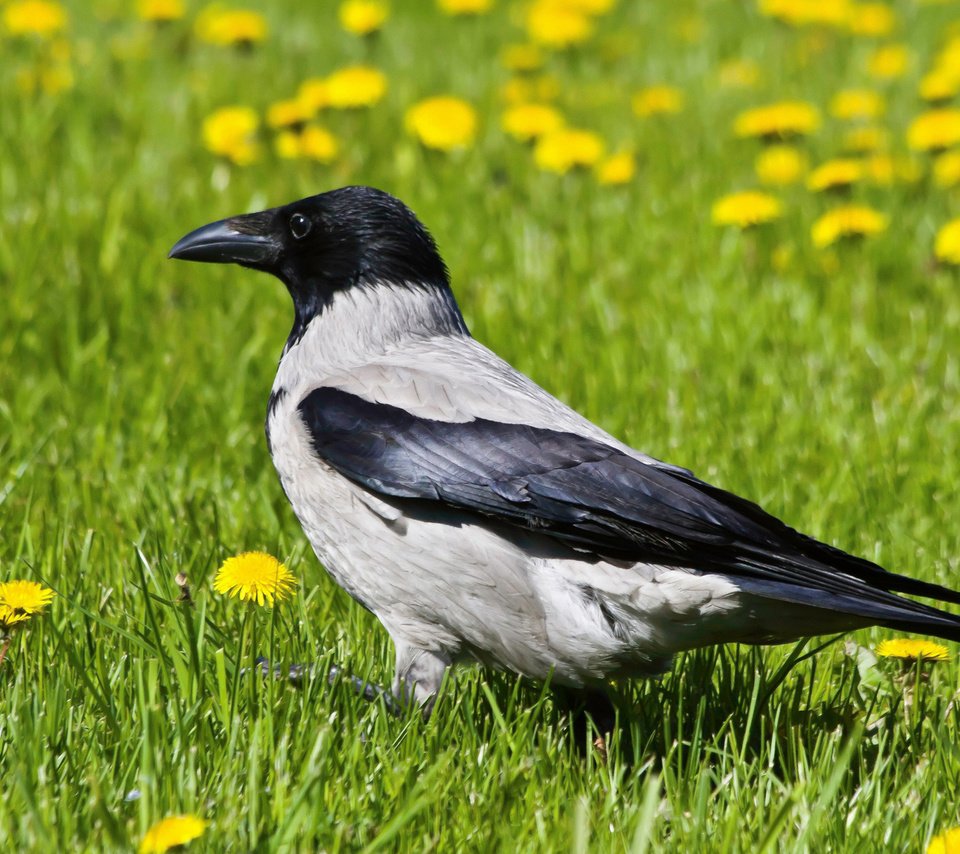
[0,0,960,852]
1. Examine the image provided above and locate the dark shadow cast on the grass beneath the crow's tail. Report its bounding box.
[460,638,936,780]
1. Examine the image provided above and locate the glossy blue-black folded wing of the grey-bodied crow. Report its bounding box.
[299,388,960,639]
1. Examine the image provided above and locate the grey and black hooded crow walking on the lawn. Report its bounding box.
[169,186,960,713]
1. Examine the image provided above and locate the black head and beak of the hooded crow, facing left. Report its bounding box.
[170,187,452,332]
